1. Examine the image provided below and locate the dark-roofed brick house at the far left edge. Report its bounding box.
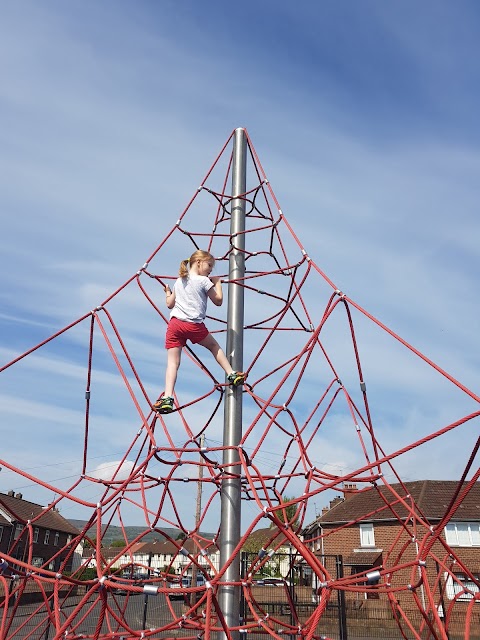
[0,491,81,573]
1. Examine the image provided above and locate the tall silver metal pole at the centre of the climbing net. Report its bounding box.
[219,129,247,637]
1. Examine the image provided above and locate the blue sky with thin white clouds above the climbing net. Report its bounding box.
[0,0,480,523]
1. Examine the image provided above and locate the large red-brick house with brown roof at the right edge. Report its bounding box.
[303,480,480,605]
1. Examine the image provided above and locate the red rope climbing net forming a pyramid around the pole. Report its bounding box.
[0,127,480,639]
